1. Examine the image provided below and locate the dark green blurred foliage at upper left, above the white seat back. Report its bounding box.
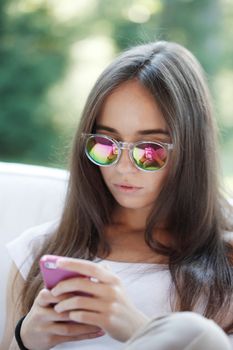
[0,1,68,163]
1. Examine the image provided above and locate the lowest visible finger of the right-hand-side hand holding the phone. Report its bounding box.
[54,297,108,313]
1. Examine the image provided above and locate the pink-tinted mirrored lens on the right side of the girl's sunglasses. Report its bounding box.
[133,143,167,170]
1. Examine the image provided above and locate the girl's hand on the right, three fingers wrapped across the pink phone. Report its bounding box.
[51,258,149,342]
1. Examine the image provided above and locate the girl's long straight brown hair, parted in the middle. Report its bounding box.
[22,41,233,332]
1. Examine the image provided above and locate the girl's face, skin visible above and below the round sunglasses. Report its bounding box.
[96,80,171,209]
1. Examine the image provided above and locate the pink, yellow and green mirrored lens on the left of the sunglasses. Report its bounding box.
[86,136,118,165]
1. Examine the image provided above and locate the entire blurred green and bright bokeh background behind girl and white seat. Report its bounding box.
[0,0,233,193]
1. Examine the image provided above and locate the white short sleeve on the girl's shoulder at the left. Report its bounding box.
[6,220,59,280]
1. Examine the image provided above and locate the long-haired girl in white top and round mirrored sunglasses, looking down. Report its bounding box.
[3,42,233,350]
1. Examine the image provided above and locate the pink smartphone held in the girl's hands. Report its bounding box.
[40,255,89,295]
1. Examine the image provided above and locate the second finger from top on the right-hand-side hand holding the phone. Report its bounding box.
[51,278,121,300]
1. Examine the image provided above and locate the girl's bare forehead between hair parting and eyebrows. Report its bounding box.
[97,80,167,135]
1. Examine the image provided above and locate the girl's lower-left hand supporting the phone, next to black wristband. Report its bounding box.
[21,289,104,350]
